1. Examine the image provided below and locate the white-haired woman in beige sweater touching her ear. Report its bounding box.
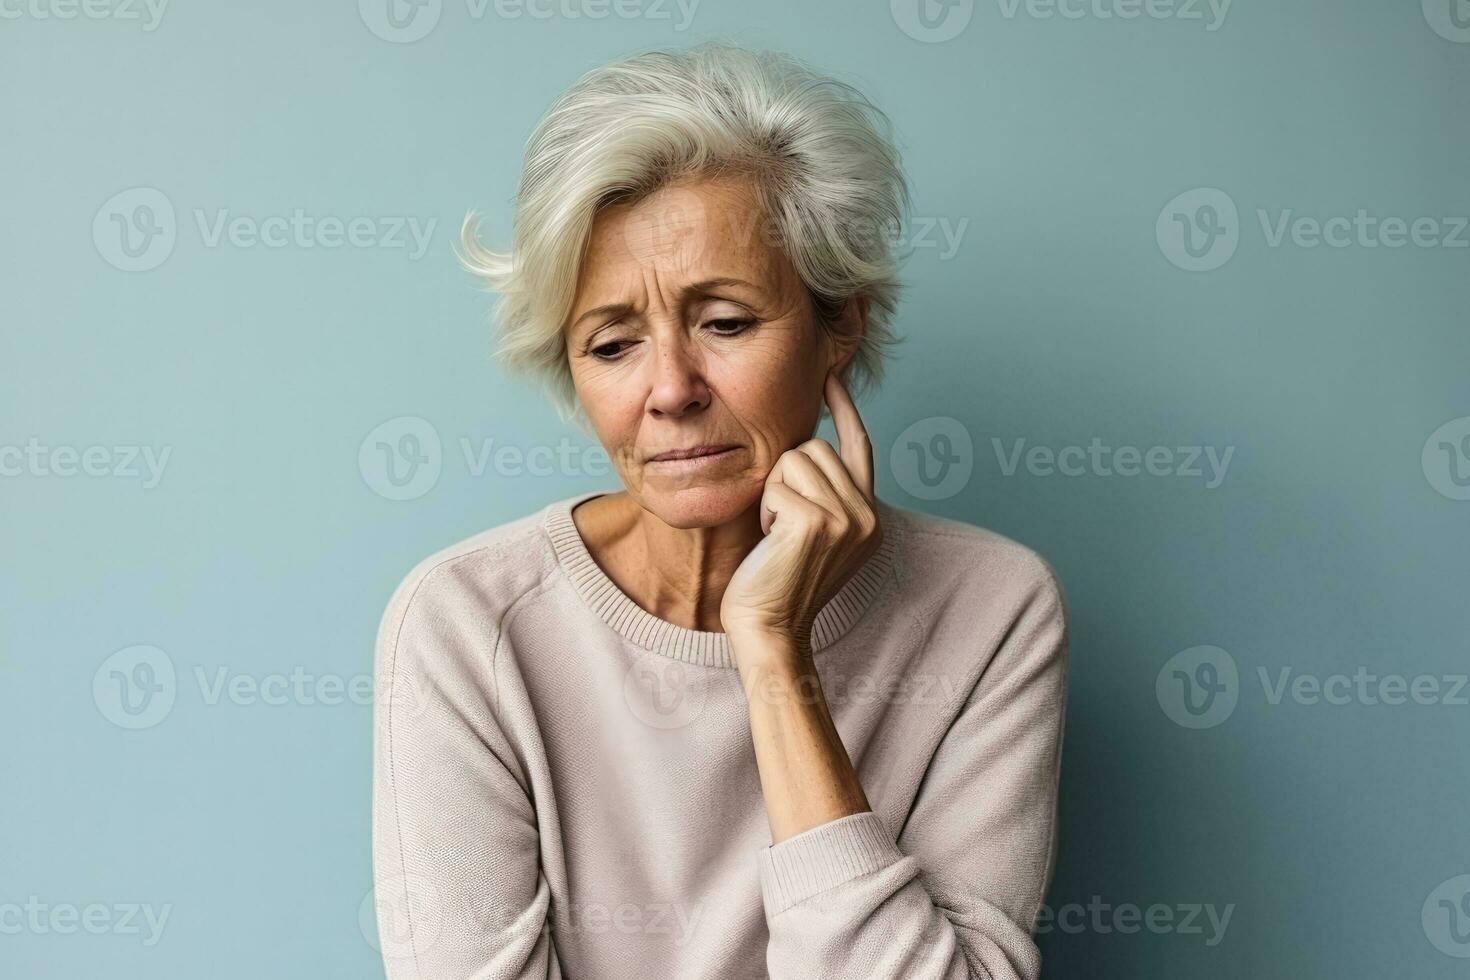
[373,46,1067,980]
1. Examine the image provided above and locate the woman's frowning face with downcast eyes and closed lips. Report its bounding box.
[566,179,860,527]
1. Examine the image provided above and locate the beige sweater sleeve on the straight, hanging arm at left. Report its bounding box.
[373,572,562,980]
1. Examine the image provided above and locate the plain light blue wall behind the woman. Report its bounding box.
[0,0,1470,980]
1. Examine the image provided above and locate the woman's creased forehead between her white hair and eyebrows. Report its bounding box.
[573,178,795,304]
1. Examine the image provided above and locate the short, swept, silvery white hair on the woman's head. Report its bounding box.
[460,43,908,422]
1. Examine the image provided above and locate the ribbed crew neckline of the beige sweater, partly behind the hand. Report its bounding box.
[541,491,897,670]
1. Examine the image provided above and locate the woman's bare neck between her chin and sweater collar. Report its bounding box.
[572,491,761,633]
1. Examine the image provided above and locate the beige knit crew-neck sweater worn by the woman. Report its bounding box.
[373,492,1067,980]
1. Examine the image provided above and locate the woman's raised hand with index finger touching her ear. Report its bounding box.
[720,373,882,655]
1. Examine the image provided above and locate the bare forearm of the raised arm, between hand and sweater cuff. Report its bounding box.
[732,635,870,843]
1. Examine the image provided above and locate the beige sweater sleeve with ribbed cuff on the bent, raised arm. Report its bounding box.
[759,560,1067,980]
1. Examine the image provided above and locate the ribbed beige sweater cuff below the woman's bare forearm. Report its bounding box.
[756,811,904,917]
